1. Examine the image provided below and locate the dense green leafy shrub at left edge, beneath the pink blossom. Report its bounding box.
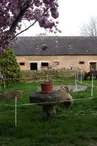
[0,48,20,84]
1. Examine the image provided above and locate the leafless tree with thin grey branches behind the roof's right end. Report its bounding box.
[81,17,97,36]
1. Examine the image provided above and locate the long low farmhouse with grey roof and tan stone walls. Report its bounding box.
[13,36,97,71]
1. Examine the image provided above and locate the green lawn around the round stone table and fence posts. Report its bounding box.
[0,78,97,146]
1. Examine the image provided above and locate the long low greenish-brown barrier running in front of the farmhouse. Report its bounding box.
[21,69,75,82]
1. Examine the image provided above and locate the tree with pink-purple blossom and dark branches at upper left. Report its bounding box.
[0,0,59,53]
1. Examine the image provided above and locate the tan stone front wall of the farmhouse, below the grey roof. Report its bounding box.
[16,55,97,71]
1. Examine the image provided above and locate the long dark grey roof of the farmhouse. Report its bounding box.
[13,36,97,56]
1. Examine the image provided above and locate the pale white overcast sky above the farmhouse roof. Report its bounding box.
[21,0,97,36]
